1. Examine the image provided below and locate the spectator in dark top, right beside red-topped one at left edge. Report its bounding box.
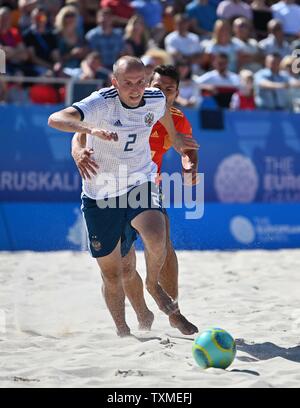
[24,7,60,75]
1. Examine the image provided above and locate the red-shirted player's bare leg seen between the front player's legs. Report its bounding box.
[122,246,154,330]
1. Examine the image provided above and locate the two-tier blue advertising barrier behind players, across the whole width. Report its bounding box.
[0,105,300,251]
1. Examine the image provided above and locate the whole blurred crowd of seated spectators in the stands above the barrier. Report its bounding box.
[0,0,300,111]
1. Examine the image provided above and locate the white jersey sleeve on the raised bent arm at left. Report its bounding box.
[72,92,107,126]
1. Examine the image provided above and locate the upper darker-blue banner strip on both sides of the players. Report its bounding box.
[0,105,300,203]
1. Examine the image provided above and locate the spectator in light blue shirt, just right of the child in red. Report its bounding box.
[254,54,290,110]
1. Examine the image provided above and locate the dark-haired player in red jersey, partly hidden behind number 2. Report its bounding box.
[72,65,198,334]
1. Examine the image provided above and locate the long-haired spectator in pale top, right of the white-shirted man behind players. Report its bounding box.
[204,20,238,72]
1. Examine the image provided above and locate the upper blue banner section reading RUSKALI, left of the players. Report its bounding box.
[0,105,81,201]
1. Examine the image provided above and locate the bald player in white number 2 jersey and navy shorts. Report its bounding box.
[48,57,198,336]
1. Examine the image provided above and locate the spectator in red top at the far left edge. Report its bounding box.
[0,7,28,75]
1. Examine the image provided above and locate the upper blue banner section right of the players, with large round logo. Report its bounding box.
[163,110,300,203]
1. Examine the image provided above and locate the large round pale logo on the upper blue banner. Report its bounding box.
[214,154,259,203]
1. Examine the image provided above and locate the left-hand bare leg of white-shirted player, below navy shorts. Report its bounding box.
[97,242,130,337]
